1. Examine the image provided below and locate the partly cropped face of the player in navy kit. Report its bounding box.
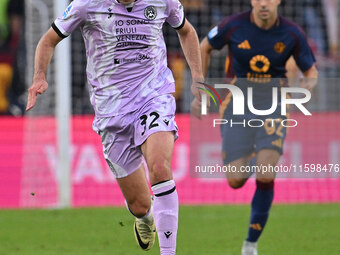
[251,0,281,21]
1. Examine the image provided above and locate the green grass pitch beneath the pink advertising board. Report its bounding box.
[0,204,340,255]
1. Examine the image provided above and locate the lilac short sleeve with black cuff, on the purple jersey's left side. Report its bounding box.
[52,0,90,38]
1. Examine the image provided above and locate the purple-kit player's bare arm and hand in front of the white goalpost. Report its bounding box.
[26,28,63,111]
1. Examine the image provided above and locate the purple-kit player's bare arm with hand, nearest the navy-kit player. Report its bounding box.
[177,19,204,101]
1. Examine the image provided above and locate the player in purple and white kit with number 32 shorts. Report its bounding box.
[26,0,203,255]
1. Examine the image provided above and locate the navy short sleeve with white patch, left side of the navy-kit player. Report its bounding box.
[207,17,231,50]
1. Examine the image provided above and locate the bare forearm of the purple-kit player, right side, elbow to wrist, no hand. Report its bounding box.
[178,24,203,79]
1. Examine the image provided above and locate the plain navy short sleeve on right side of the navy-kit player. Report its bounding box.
[293,29,315,72]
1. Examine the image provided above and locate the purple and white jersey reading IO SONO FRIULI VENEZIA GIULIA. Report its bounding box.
[52,0,185,117]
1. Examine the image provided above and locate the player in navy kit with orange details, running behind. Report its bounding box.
[197,0,318,255]
